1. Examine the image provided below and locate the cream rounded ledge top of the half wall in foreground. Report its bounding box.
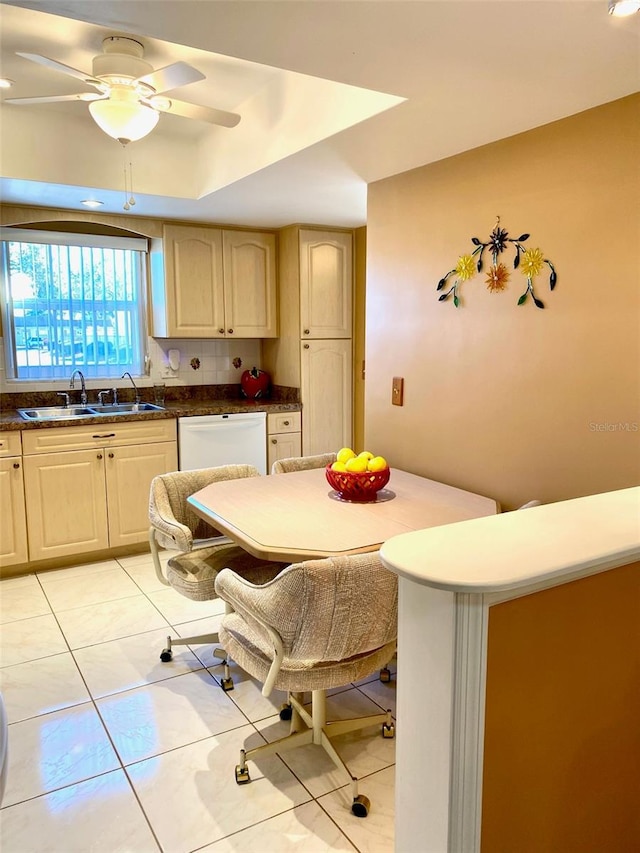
[380,487,640,593]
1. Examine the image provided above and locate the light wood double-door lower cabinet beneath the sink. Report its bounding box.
[23,420,178,561]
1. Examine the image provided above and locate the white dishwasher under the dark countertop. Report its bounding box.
[178,412,267,474]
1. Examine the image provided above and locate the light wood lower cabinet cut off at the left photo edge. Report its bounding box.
[0,432,28,566]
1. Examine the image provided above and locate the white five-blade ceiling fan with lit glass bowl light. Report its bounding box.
[4,36,240,145]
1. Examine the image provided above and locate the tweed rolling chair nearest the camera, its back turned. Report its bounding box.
[215,553,398,817]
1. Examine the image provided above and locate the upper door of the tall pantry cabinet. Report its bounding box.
[300,229,353,339]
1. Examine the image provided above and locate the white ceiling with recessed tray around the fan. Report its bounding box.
[0,0,640,227]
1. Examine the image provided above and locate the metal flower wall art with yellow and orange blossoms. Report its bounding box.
[436,216,558,308]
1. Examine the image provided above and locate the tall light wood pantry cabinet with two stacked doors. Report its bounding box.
[263,226,353,456]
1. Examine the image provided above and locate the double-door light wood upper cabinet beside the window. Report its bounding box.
[151,225,278,338]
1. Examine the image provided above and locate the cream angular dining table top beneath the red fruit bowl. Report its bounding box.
[188,468,500,563]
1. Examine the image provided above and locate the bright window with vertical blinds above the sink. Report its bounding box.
[1,228,147,380]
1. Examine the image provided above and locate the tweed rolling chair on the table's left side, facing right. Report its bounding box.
[149,465,286,690]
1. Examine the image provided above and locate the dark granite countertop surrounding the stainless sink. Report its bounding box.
[0,385,302,431]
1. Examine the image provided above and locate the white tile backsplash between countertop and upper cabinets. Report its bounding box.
[0,338,262,393]
